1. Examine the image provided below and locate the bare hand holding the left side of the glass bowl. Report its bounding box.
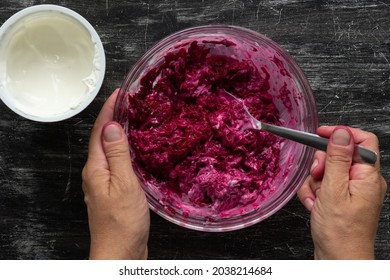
[82,90,150,259]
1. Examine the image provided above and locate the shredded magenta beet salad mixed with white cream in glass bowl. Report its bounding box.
[123,40,281,213]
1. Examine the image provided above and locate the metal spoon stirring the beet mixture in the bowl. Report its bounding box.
[225,90,378,164]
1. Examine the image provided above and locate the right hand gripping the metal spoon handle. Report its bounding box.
[298,126,387,259]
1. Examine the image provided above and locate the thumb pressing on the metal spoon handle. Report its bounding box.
[323,126,354,193]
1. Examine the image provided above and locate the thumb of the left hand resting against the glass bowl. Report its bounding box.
[102,122,132,182]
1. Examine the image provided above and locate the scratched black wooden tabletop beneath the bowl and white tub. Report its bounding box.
[0,0,390,259]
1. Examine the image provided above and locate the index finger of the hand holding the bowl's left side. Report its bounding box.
[88,89,119,163]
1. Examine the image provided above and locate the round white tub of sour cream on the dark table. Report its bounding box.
[0,5,106,122]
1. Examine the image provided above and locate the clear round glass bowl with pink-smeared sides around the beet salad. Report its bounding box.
[114,25,318,232]
